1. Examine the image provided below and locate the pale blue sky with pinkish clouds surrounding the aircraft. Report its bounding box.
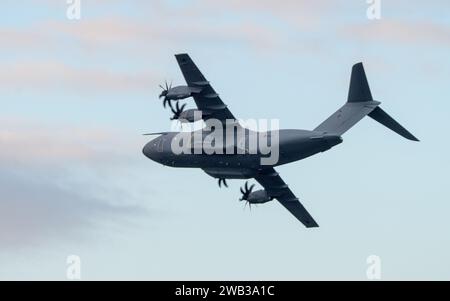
[0,0,450,280]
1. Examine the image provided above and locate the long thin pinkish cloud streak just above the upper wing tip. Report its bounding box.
[41,13,286,51]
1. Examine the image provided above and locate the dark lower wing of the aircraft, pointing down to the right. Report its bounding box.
[255,168,319,228]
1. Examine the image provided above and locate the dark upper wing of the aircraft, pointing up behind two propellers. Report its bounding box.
[175,53,236,122]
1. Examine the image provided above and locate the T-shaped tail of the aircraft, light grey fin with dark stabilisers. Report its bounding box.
[314,63,419,141]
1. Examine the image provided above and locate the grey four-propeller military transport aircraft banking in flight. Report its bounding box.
[143,54,419,228]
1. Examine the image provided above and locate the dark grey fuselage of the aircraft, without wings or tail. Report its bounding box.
[143,130,342,179]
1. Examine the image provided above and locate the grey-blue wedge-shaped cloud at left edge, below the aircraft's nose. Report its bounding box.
[0,168,144,250]
